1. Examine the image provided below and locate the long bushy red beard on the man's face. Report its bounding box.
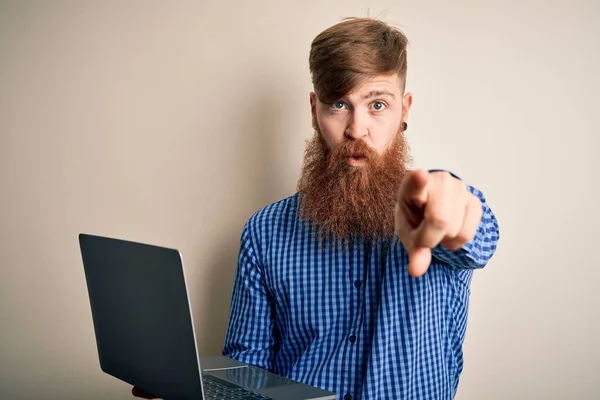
[298,131,410,243]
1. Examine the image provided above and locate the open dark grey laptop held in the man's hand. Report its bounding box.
[79,233,336,400]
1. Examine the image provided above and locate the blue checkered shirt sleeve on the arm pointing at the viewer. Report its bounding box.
[430,170,500,269]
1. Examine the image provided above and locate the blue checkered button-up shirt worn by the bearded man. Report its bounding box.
[223,182,499,400]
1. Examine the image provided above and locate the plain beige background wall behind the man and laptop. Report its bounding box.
[0,0,600,400]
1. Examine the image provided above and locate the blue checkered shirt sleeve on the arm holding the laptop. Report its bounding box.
[222,224,275,370]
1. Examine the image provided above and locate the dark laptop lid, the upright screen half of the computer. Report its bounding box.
[79,234,202,399]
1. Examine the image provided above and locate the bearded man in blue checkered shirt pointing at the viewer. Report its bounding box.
[134,18,499,400]
